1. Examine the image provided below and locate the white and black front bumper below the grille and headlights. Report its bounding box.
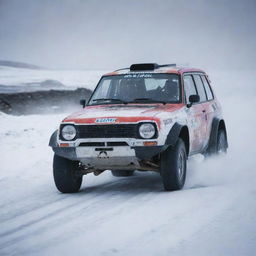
[49,131,165,169]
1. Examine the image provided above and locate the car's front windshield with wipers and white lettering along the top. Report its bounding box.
[88,73,180,105]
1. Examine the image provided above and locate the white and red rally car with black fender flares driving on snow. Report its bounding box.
[49,63,228,193]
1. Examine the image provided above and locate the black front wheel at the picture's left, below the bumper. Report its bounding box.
[53,154,82,193]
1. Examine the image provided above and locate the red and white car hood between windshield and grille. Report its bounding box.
[63,104,184,124]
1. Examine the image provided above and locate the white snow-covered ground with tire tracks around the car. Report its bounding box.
[0,71,256,256]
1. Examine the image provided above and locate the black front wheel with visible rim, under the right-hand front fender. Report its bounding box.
[160,139,187,191]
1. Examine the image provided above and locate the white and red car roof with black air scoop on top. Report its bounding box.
[104,63,205,76]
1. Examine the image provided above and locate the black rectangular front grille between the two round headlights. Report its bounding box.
[76,124,138,138]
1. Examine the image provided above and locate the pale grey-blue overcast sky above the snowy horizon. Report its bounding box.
[0,0,256,69]
